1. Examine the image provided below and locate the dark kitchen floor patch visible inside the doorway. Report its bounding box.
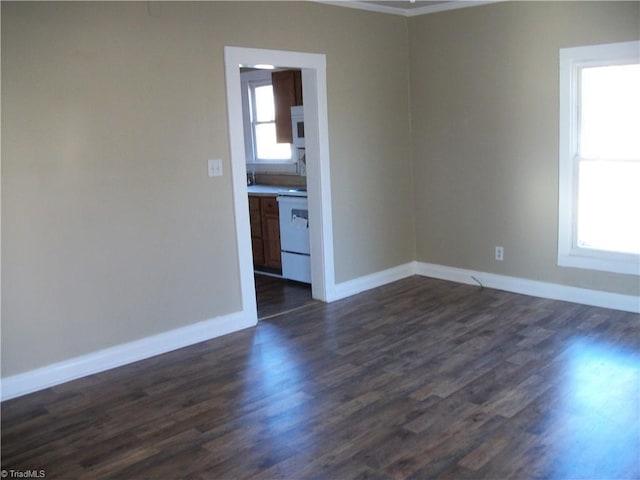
[254,274,315,320]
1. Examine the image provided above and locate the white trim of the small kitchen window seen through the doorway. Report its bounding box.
[240,70,297,174]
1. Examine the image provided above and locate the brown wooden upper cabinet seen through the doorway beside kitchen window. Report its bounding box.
[271,70,302,143]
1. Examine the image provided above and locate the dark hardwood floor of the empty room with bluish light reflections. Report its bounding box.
[2,277,640,480]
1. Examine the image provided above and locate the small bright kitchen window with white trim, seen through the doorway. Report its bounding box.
[241,70,296,173]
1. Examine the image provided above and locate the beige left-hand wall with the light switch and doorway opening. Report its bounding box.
[2,2,414,377]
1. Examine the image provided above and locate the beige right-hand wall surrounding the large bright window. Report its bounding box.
[409,2,640,295]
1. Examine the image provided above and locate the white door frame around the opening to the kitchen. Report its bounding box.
[224,47,335,321]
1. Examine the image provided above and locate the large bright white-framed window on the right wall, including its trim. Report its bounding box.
[558,41,640,275]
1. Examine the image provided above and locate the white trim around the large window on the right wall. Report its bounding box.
[558,41,640,275]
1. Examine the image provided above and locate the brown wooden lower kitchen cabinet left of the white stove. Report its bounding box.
[249,195,282,274]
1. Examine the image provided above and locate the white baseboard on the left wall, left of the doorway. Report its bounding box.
[0,312,257,401]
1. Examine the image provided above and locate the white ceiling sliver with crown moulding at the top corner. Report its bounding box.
[317,0,504,17]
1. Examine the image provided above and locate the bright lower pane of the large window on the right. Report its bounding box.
[578,161,640,254]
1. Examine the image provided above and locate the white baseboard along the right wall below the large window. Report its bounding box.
[416,262,640,313]
